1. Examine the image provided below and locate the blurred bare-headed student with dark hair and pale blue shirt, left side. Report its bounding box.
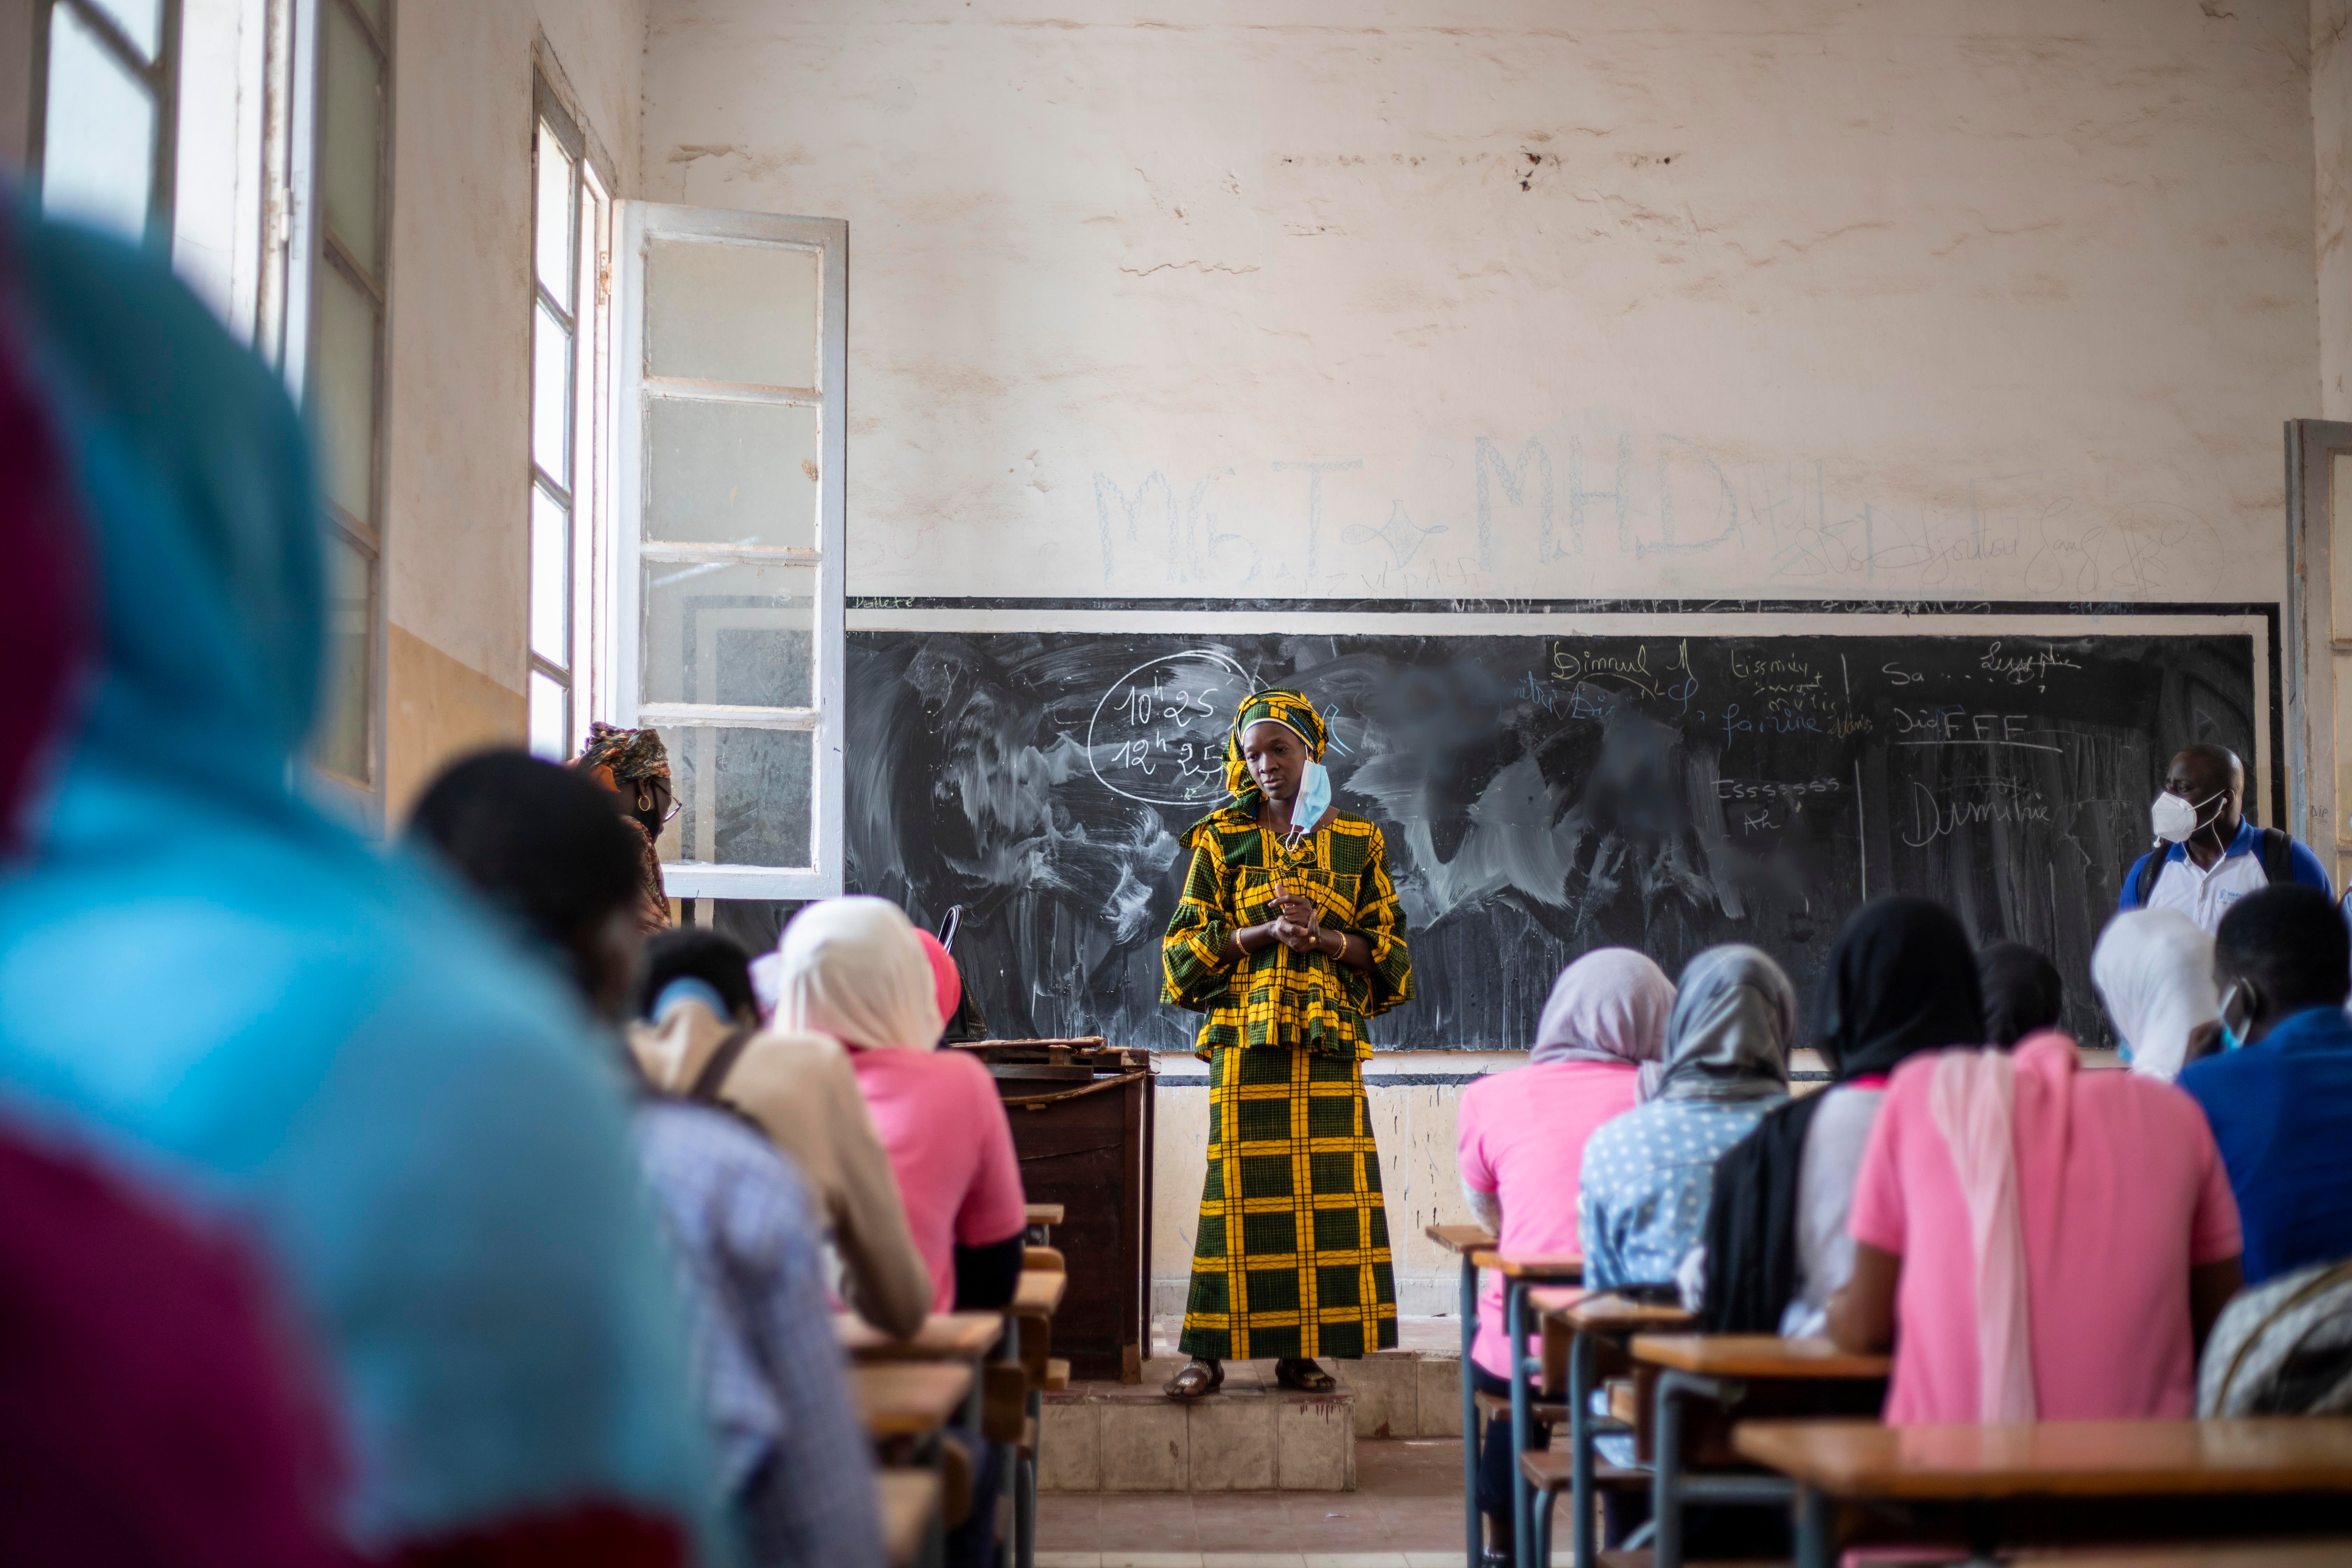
[409,752,882,1568]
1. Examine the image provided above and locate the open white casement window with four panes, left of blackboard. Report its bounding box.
[611,202,849,898]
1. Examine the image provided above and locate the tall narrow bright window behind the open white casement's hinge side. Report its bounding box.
[527,87,604,762]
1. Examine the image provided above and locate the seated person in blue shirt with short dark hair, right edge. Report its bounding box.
[2180,884,2352,1286]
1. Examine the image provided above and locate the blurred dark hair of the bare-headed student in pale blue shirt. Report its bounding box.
[407,750,640,957]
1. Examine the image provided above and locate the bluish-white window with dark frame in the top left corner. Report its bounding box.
[30,0,179,247]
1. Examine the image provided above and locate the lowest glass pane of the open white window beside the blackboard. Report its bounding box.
[661,726,816,867]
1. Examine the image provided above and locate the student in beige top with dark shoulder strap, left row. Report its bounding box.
[628,926,934,1338]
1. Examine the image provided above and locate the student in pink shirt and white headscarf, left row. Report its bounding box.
[774,898,1028,1312]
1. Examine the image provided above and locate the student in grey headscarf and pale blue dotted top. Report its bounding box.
[1578,945,1797,1288]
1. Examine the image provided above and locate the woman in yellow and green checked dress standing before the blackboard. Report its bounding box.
[1160,691,1414,1399]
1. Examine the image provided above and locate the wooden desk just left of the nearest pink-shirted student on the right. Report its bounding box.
[1632,1333,1893,1568]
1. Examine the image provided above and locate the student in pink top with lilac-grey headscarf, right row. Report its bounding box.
[1456,947,1675,1556]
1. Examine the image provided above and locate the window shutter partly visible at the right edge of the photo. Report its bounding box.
[2286,419,2352,891]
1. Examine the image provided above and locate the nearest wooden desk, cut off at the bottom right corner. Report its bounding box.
[1734,1415,2352,1568]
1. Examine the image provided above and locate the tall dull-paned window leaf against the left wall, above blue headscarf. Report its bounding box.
[301,0,393,790]
